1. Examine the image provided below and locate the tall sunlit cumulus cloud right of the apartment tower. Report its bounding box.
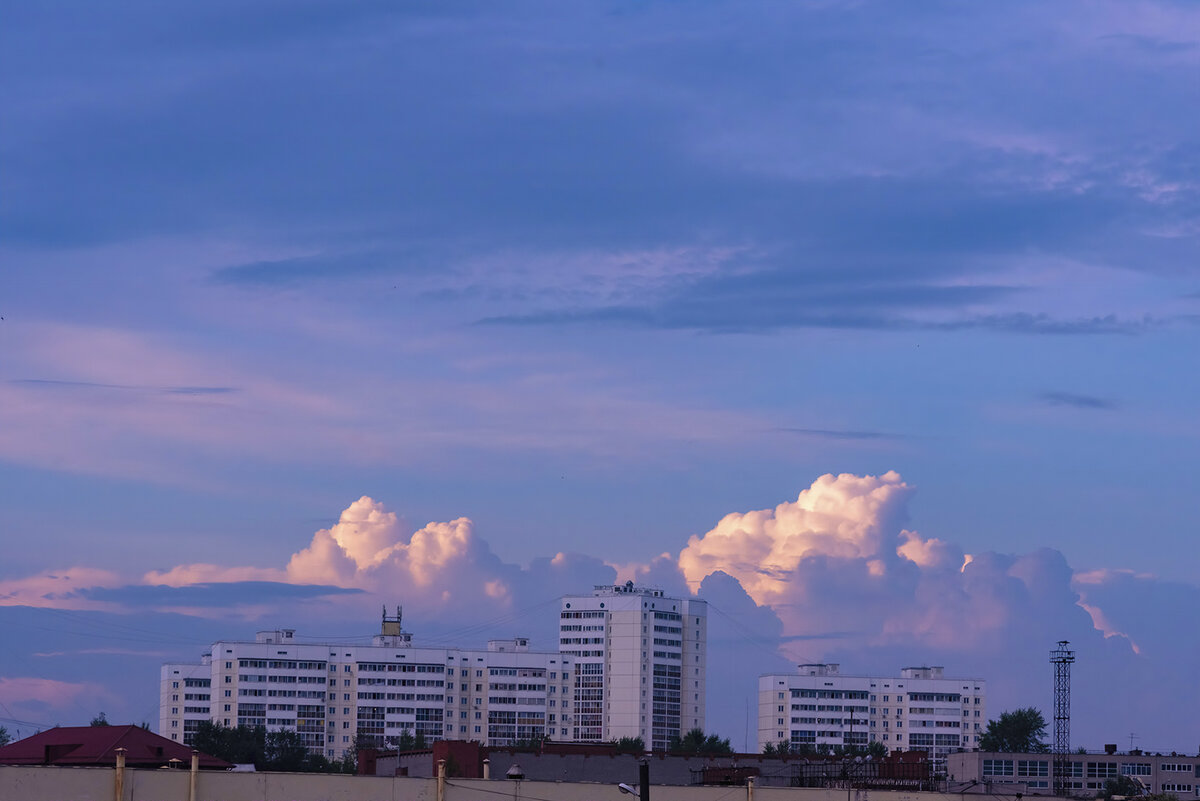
[679,472,1108,658]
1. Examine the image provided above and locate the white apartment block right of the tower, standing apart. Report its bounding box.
[758,664,988,764]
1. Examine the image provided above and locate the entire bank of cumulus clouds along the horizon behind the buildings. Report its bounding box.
[0,472,1200,753]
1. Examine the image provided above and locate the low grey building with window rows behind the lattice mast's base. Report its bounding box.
[947,747,1200,801]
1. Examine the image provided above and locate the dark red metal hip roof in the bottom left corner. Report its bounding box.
[0,725,233,770]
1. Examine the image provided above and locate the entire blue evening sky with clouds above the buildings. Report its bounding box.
[0,0,1200,752]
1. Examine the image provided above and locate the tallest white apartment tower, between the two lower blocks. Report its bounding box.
[558,582,708,749]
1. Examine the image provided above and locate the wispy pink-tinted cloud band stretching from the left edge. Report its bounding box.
[0,320,773,488]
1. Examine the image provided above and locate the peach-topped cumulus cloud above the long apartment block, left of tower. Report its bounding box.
[125,495,619,648]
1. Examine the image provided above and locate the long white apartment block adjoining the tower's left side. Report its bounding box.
[158,614,576,758]
